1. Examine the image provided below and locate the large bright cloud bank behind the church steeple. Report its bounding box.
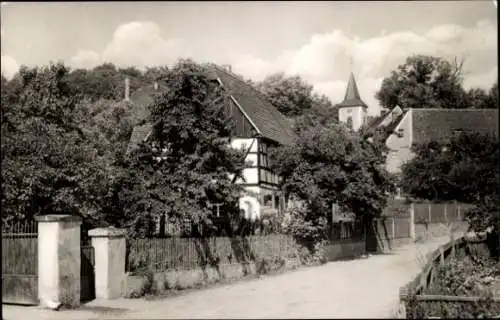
[233,20,498,114]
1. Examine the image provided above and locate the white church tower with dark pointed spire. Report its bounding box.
[337,72,368,131]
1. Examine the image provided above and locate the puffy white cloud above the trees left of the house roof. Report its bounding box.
[70,21,192,69]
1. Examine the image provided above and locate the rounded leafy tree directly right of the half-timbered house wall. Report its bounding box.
[271,125,394,248]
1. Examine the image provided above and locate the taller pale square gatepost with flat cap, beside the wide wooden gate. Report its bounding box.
[36,214,82,309]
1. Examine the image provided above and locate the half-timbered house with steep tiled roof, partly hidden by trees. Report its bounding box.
[127,64,296,216]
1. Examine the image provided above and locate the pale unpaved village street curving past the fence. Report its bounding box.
[2,237,458,320]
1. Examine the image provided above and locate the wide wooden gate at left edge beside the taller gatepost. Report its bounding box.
[2,221,38,305]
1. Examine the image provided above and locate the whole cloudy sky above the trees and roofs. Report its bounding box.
[0,0,498,115]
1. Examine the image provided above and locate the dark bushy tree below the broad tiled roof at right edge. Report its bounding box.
[402,133,500,203]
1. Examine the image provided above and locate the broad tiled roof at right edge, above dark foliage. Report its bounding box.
[412,109,498,143]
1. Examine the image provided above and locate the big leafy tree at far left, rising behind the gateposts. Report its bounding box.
[1,64,117,226]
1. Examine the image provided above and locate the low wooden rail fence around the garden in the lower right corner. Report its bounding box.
[399,237,500,318]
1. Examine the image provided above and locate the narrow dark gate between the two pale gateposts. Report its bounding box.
[80,242,95,302]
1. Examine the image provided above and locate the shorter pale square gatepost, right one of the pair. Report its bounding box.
[89,228,126,299]
